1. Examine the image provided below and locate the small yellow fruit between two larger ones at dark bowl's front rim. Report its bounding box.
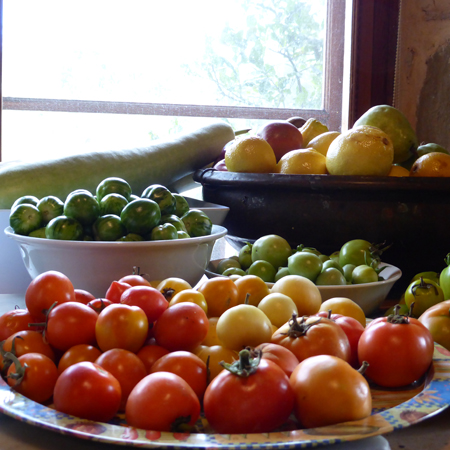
[277,148,327,175]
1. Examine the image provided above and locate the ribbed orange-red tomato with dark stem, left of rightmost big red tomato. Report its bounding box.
[272,316,351,362]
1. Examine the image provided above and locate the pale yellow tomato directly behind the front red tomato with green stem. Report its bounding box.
[217,305,273,351]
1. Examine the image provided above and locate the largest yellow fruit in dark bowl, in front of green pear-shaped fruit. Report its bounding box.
[326,125,394,176]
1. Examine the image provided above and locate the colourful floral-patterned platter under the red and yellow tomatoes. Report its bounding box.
[0,344,450,450]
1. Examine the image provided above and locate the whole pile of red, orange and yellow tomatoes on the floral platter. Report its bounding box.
[0,271,434,433]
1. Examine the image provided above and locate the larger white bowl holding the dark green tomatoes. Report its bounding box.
[5,225,227,297]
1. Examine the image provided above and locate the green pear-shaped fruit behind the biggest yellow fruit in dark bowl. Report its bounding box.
[354,105,419,163]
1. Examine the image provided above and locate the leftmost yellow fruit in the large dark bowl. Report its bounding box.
[225,136,277,173]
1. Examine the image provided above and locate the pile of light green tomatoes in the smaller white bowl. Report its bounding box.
[217,234,389,286]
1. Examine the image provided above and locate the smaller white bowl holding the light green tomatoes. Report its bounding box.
[205,260,402,316]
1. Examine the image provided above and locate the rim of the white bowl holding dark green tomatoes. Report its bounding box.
[4,225,228,248]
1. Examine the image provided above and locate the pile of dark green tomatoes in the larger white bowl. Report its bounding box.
[9,177,212,241]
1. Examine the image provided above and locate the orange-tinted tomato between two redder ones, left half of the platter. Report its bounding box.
[95,303,148,353]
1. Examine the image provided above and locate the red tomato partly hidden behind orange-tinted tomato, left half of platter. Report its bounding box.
[120,286,169,323]
